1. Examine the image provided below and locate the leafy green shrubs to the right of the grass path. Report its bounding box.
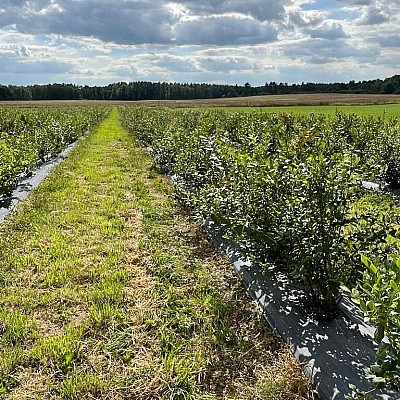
[120,108,400,396]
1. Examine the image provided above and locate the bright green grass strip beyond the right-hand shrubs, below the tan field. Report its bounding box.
[187,104,400,118]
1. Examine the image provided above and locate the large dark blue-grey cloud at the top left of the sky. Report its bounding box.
[0,0,176,44]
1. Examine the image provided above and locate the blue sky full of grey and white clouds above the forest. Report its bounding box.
[0,0,400,86]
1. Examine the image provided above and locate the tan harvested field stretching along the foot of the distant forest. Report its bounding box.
[0,93,400,108]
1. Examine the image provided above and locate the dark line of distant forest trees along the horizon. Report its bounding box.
[0,75,400,101]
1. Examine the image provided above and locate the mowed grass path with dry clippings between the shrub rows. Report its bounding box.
[0,110,315,399]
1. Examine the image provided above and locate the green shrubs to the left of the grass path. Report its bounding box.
[0,108,108,195]
